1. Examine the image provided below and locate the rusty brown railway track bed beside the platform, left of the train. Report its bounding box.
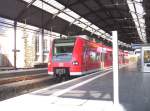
[0,73,58,101]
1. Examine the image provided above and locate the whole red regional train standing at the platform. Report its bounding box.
[48,35,127,77]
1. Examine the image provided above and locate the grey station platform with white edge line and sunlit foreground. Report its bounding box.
[0,64,150,111]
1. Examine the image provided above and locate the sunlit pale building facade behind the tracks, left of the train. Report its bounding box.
[0,18,60,68]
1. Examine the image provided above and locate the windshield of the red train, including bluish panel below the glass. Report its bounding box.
[53,39,75,62]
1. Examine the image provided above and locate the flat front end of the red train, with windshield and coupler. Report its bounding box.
[48,37,80,77]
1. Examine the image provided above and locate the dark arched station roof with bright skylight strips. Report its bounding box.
[0,0,150,46]
